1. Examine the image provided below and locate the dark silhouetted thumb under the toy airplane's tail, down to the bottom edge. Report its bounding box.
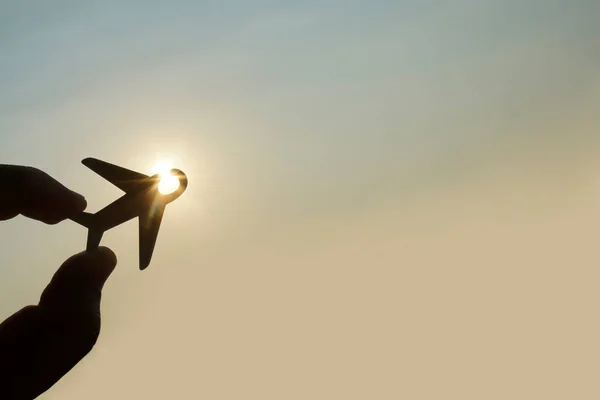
[0,247,117,399]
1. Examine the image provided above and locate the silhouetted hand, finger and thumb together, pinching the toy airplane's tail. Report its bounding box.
[0,165,117,400]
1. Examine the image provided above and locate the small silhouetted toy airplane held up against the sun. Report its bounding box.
[71,158,187,270]
